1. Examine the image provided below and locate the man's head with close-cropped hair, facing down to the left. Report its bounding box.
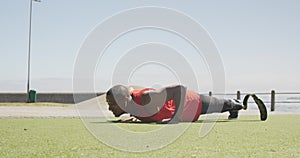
[106,85,131,117]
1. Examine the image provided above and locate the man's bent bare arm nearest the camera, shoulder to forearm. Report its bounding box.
[141,85,186,122]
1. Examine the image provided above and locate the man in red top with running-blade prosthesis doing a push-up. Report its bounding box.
[106,85,267,123]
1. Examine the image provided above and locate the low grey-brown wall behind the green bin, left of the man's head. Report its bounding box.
[0,93,104,104]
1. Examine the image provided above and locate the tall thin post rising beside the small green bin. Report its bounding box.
[27,0,41,102]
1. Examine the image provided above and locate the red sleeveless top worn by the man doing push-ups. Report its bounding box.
[130,88,202,122]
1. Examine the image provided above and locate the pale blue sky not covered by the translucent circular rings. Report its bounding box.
[0,0,300,92]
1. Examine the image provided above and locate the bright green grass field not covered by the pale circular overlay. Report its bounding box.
[0,115,300,157]
